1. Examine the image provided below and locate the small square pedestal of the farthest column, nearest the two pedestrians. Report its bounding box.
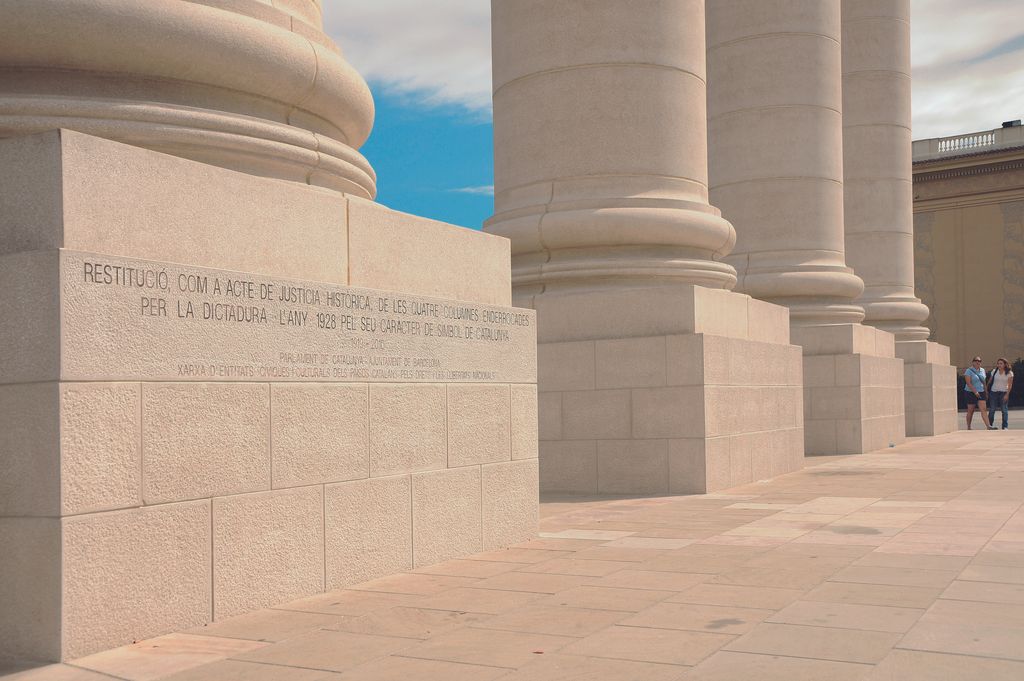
[896,340,958,437]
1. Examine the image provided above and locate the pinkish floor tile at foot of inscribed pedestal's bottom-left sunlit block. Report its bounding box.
[74,634,269,681]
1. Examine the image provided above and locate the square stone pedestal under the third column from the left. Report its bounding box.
[793,324,906,456]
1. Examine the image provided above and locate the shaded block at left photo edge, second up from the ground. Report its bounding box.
[0,382,60,516]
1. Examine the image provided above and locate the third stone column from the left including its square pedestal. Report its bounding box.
[708,0,904,454]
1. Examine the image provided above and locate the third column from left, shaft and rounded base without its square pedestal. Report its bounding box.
[708,0,863,326]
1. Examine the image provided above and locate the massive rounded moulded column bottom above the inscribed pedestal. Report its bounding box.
[0,0,376,199]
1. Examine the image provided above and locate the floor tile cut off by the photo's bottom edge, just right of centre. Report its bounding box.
[491,654,685,681]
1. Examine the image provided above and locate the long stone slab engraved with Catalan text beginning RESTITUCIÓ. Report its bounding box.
[61,251,537,383]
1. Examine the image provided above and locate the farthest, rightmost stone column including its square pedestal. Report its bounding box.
[843,0,956,435]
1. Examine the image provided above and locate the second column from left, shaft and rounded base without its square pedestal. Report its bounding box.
[485,0,735,295]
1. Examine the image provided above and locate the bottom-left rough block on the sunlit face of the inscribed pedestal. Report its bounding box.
[61,500,211,659]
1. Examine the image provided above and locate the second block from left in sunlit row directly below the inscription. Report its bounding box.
[142,383,270,504]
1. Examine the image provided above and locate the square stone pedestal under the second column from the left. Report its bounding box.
[518,285,804,495]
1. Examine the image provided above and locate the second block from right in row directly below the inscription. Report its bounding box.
[447,383,512,468]
